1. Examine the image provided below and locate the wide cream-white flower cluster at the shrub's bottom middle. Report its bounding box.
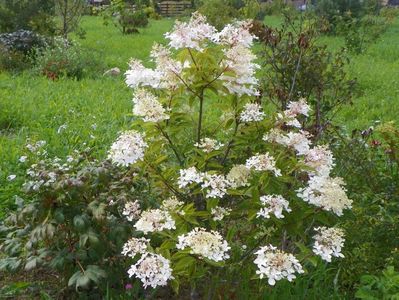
[176,228,230,262]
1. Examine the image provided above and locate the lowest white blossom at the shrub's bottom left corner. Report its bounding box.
[128,253,174,288]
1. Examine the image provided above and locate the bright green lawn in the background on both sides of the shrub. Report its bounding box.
[0,17,399,211]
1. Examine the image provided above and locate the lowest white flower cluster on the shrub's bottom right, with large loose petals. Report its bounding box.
[254,245,304,285]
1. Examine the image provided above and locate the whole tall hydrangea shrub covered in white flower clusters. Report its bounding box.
[109,14,352,292]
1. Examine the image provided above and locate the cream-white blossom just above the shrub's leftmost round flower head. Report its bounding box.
[133,89,169,122]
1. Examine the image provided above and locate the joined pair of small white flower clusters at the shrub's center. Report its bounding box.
[178,167,230,198]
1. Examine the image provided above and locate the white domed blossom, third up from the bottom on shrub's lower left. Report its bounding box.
[134,209,176,234]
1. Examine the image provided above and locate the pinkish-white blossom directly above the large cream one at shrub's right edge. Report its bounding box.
[305,146,335,177]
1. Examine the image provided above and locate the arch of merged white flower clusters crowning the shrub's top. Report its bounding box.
[125,13,259,95]
